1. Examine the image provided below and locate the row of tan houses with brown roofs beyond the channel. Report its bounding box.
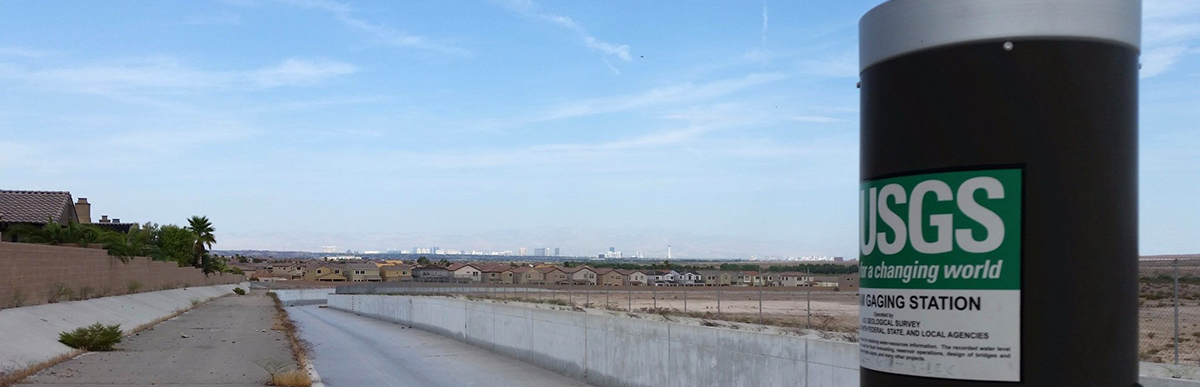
[244,261,858,290]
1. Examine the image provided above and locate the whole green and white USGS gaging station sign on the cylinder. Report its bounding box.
[858,168,1022,382]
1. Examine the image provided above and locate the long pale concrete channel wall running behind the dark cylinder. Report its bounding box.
[329,294,1200,387]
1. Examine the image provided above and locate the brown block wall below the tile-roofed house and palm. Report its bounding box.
[0,243,244,308]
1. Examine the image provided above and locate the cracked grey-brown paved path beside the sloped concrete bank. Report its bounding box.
[17,292,292,387]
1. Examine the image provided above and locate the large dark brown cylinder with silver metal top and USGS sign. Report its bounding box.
[859,0,1141,387]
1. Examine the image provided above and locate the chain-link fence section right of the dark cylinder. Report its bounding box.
[1138,258,1200,364]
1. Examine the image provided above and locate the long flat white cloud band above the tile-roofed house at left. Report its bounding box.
[0,58,358,94]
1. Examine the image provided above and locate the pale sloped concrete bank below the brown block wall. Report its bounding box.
[0,284,248,369]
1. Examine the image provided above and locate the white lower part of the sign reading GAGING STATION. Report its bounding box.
[858,288,1021,382]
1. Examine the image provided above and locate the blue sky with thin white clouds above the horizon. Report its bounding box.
[0,0,1200,257]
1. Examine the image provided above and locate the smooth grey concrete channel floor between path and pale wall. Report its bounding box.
[288,306,588,387]
